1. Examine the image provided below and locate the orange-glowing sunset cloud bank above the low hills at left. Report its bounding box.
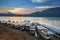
[0,8,36,14]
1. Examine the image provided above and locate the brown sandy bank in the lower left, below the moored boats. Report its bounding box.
[0,24,36,40]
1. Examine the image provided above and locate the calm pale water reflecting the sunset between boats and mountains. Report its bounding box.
[0,17,60,30]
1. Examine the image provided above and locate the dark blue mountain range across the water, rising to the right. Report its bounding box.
[0,7,60,17]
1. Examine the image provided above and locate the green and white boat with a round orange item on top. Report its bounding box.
[35,25,53,40]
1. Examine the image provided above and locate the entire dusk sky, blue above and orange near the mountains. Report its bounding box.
[0,0,60,14]
